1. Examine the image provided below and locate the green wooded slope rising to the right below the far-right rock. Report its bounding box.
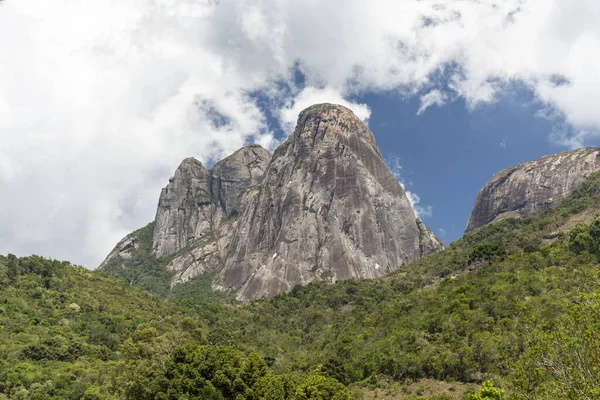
[188,170,600,399]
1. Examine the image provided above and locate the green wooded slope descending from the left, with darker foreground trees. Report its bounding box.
[0,255,350,400]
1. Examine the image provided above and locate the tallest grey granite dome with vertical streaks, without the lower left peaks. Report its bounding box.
[216,104,443,300]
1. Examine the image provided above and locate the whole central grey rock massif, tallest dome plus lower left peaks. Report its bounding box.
[100,104,443,300]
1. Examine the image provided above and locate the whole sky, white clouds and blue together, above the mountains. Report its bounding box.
[0,0,600,268]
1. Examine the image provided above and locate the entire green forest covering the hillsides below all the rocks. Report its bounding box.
[0,174,600,400]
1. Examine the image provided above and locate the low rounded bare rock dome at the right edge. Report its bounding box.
[466,148,600,232]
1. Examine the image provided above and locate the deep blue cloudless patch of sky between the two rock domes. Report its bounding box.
[361,89,567,243]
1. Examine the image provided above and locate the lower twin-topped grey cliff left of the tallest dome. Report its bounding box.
[99,145,271,280]
